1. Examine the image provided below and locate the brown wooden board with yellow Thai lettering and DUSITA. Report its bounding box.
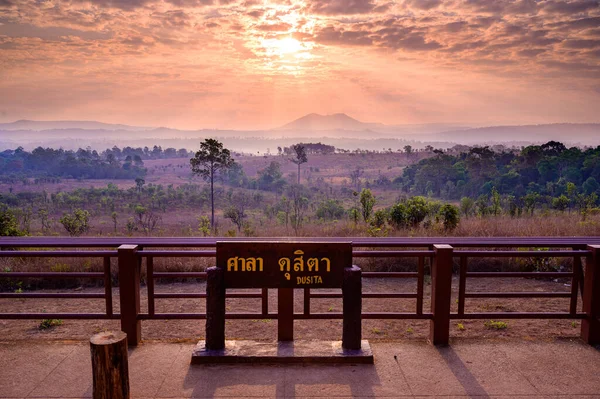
[217,241,352,288]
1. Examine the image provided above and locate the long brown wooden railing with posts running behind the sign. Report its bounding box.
[0,237,600,345]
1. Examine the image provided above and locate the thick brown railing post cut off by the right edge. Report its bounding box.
[581,245,600,345]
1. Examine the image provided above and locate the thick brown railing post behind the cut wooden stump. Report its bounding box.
[118,245,142,346]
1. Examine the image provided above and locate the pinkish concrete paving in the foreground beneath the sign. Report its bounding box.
[0,340,600,399]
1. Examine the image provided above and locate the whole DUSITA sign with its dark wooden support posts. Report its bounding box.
[192,241,372,363]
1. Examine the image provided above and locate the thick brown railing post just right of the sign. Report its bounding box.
[429,244,453,345]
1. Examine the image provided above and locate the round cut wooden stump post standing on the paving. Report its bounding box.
[90,331,129,399]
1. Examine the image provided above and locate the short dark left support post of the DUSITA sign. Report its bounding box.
[205,267,225,350]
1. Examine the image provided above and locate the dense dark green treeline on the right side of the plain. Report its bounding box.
[394,141,600,199]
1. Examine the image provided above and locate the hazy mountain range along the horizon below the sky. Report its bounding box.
[0,113,600,152]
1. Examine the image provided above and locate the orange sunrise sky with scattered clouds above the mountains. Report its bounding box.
[0,0,600,129]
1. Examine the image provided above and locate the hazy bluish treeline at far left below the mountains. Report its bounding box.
[0,146,191,179]
